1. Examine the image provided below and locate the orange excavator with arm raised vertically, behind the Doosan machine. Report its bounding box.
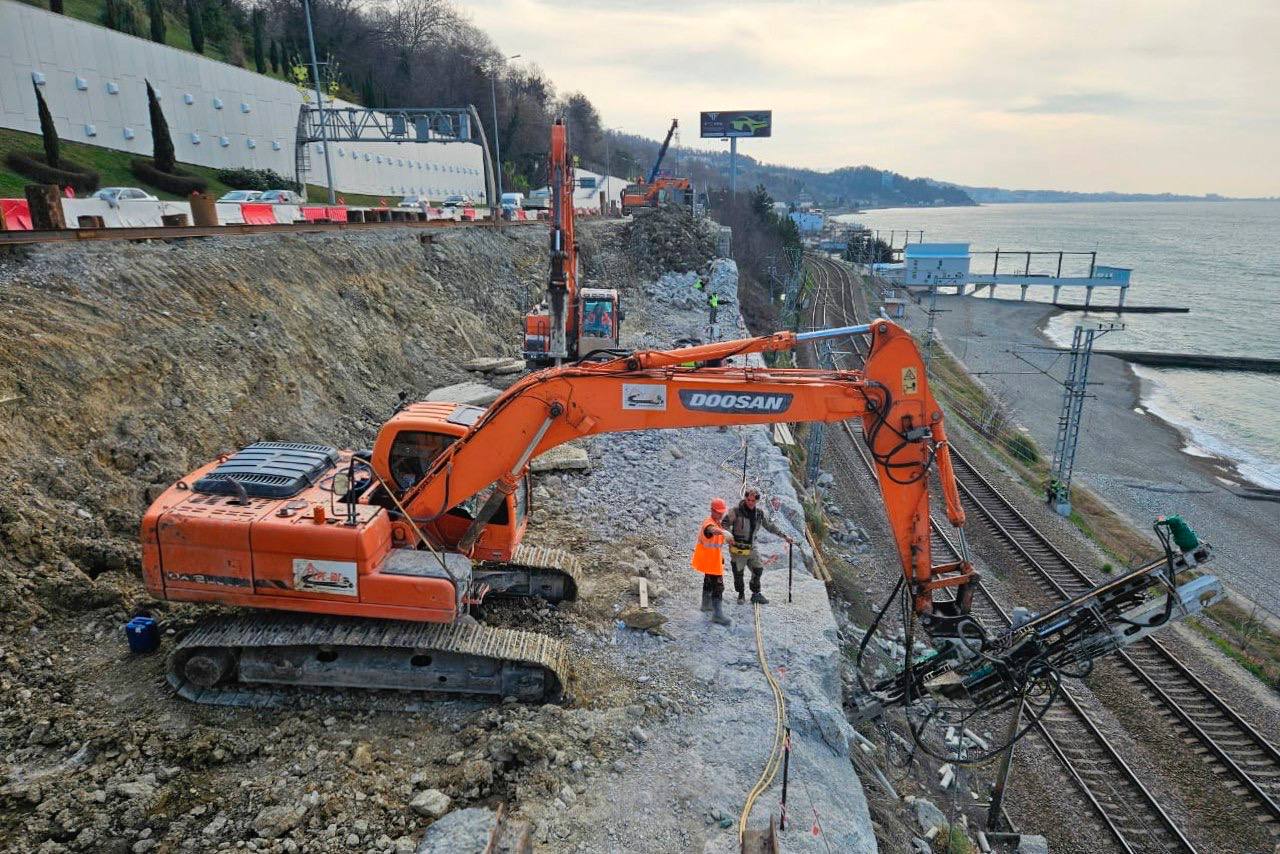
[524,118,622,369]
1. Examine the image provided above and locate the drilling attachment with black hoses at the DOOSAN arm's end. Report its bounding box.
[872,516,1225,709]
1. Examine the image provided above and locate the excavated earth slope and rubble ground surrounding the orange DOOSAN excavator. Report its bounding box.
[0,224,874,854]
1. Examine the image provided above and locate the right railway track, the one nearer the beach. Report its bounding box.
[813,248,1280,839]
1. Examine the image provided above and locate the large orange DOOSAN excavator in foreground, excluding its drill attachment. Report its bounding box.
[142,320,974,704]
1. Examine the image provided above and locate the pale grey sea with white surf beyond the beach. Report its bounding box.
[837,201,1280,489]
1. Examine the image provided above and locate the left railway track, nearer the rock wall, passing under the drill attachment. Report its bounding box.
[813,261,1197,853]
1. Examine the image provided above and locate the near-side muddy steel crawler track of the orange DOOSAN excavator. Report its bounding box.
[168,613,571,711]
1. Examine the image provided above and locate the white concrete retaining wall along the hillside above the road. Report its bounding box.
[0,0,484,202]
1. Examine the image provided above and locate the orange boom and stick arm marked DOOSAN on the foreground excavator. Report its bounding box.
[403,320,975,613]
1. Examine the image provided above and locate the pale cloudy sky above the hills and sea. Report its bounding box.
[457,0,1280,196]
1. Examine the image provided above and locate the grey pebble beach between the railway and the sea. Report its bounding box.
[906,294,1280,616]
